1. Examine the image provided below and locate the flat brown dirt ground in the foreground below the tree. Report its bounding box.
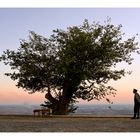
[0,115,140,132]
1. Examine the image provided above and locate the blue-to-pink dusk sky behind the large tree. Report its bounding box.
[0,8,140,104]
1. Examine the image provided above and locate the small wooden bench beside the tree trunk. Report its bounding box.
[33,108,52,117]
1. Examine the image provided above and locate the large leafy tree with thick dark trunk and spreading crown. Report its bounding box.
[1,20,139,114]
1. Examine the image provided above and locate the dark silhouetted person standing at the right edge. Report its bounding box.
[132,89,140,119]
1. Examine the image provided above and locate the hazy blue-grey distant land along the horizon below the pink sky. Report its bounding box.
[0,104,133,116]
